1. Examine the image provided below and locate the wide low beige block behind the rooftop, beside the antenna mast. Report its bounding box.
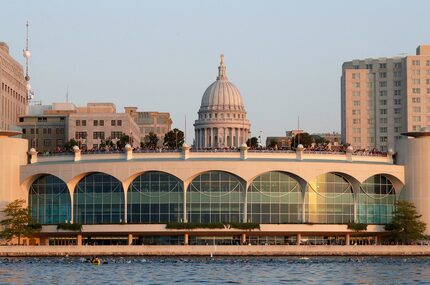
[18,103,140,152]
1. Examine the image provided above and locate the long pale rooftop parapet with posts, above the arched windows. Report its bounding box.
[29,145,395,164]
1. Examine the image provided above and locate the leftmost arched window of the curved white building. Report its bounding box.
[28,175,71,225]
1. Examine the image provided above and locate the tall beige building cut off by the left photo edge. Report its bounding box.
[0,42,27,130]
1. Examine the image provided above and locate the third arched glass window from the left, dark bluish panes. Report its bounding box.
[127,172,184,224]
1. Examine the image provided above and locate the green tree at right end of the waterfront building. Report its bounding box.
[385,201,426,244]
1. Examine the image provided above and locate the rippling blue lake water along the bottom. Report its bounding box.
[0,257,430,284]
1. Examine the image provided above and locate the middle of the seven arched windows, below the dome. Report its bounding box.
[187,171,245,223]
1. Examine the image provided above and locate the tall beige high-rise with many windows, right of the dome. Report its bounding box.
[341,45,430,151]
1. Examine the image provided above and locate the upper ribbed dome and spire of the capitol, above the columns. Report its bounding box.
[200,55,245,111]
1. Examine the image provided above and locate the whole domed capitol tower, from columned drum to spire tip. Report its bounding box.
[194,55,251,148]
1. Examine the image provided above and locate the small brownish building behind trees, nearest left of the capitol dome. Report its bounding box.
[124,107,173,147]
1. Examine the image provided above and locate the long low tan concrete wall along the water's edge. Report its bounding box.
[0,245,430,257]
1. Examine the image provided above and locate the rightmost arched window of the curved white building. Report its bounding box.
[357,174,396,224]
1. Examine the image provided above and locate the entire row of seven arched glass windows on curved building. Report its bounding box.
[28,171,405,225]
